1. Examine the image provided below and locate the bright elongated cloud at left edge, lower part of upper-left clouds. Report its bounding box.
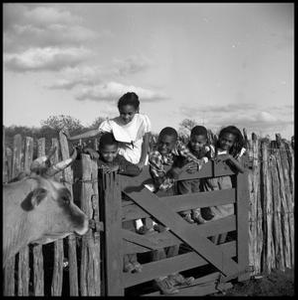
[4,47,90,72]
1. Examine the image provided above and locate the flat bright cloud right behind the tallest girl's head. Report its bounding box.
[76,82,167,102]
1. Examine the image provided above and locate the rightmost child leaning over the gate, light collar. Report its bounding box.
[202,126,246,244]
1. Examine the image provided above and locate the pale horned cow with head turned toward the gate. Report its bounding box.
[3,148,89,267]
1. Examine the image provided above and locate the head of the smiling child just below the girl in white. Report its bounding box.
[98,132,118,162]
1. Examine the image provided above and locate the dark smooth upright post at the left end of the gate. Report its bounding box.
[102,172,124,296]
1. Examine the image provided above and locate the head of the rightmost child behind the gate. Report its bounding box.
[217,125,244,156]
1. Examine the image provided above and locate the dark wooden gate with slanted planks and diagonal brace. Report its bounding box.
[99,161,249,296]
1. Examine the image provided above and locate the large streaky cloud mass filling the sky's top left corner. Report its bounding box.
[3,4,101,71]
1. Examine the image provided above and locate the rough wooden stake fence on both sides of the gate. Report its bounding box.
[3,134,294,296]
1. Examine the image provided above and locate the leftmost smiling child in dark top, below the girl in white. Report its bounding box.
[84,132,142,273]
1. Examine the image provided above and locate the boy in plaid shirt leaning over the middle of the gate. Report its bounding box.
[149,127,194,294]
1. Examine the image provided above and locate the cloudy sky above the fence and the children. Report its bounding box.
[3,3,294,139]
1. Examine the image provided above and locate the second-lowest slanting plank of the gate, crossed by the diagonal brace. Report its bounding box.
[123,241,236,288]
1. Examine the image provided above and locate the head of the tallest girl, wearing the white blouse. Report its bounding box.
[118,92,140,124]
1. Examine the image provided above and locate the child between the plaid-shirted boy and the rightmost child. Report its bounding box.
[177,126,214,224]
